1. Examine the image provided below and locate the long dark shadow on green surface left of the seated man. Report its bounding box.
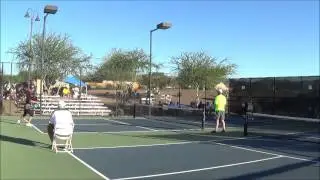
[0,134,50,149]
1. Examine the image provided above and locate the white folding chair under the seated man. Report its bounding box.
[52,125,74,153]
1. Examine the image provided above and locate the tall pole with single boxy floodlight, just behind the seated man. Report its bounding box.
[40,5,58,114]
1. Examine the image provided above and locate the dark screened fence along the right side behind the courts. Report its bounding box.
[229,76,320,118]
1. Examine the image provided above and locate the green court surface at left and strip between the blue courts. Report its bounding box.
[0,116,242,179]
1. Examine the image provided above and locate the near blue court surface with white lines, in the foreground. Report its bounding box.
[73,139,320,180]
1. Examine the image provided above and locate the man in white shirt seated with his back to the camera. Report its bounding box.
[47,101,74,146]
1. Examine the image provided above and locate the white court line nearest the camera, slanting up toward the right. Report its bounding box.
[114,156,282,180]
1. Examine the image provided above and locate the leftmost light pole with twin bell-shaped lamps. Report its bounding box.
[24,8,40,88]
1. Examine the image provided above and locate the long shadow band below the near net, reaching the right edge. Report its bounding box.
[129,131,320,159]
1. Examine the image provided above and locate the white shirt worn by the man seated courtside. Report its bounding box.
[49,109,74,134]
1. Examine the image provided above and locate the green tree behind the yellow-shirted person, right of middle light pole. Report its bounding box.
[171,51,237,100]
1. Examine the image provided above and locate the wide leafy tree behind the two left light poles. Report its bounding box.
[9,33,92,88]
